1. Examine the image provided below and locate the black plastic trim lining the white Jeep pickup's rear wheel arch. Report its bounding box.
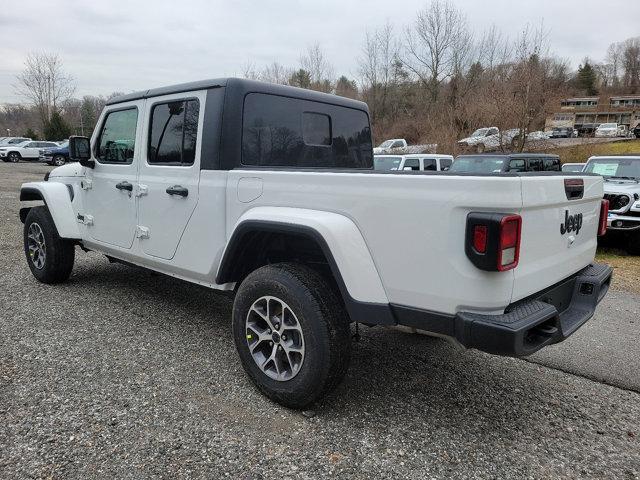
[215,220,397,325]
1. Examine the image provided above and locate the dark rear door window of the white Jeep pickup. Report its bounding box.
[147,99,200,166]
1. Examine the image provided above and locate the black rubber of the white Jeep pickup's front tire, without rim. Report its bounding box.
[24,207,75,284]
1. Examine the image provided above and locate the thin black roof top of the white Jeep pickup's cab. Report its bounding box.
[107,78,369,112]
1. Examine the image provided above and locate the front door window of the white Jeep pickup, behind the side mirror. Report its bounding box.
[96,107,138,165]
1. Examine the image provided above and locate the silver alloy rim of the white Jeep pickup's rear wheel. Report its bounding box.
[245,296,304,382]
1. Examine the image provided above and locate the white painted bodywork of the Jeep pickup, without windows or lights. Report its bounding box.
[20,84,602,320]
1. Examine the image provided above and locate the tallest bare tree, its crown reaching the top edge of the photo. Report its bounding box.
[404,0,471,100]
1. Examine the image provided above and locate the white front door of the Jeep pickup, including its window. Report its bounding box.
[82,101,144,248]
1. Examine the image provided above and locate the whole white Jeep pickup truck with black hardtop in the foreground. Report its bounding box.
[20,79,611,408]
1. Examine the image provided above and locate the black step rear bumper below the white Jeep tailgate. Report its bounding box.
[454,263,613,357]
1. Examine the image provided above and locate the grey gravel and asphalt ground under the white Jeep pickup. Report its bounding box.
[0,164,640,479]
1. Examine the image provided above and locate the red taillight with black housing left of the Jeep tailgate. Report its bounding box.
[465,212,522,272]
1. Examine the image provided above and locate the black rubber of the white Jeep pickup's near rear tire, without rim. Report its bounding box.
[232,263,351,409]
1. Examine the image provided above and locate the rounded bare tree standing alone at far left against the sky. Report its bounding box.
[15,53,75,126]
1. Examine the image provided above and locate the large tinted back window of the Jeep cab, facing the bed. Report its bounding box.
[242,93,373,168]
